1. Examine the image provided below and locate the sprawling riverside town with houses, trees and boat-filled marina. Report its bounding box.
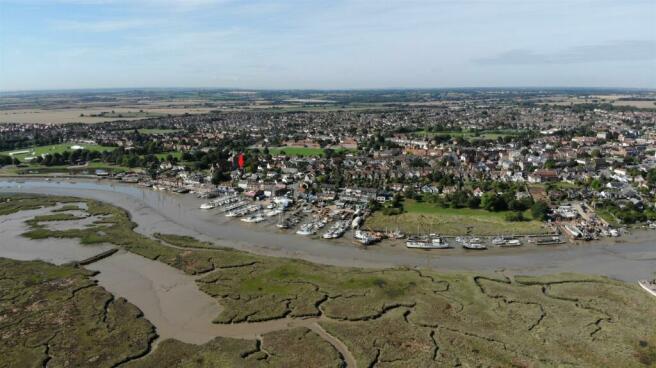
[0,90,656,250]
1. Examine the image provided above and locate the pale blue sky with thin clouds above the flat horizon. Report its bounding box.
[0,0,656,91]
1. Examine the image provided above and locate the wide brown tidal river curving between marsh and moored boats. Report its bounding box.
[0,179,656,282]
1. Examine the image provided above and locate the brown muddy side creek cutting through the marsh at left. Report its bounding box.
[0,205,354,360]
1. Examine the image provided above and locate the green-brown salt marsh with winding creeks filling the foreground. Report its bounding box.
[5,195,656,367]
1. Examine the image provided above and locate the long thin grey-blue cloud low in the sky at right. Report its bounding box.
[474,40,656,65]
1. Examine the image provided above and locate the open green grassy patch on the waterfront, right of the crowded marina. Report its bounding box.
[365,200,547,235]
